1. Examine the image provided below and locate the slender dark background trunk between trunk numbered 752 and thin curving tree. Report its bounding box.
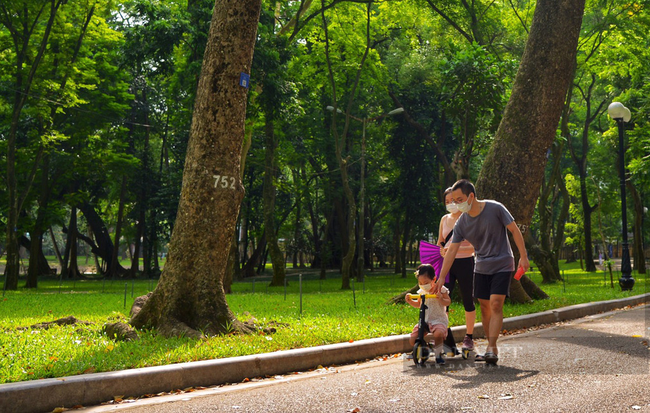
[262,119,286,287]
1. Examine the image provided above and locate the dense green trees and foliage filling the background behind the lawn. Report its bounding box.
[0,0,650,326]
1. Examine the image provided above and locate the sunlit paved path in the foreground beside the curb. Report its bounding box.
[78,305,650,413]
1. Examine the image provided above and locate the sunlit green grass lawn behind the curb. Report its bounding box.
[0,264,648,383]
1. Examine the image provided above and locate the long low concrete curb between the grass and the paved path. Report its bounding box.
[0,293,650,413]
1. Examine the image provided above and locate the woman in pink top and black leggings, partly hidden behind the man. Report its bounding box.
[438,188,476,356]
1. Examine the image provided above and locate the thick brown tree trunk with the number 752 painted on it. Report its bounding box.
[131,0,260,337]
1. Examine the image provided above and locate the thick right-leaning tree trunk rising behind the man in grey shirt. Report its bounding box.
[476,0,584,302]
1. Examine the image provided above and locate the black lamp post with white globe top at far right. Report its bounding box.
[607,102,634,291]
